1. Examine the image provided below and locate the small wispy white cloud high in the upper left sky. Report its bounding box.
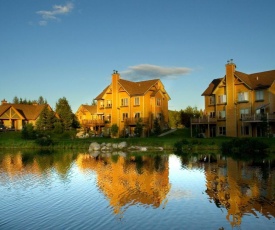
[36,3,74,26]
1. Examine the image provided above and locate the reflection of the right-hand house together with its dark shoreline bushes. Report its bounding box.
[177,154,275,227]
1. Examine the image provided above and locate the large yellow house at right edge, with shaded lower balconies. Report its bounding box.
[191,60,275,137]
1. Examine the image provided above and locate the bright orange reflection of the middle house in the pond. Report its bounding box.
[77,154,170,214]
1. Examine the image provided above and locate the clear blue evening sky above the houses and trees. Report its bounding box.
[0,0,275,112]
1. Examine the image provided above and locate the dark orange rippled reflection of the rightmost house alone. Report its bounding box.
[205,158,275,227]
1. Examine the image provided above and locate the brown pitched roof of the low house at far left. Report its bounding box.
[0,103,48,120]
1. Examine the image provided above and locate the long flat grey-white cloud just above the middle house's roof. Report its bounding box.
[121,64,192,80]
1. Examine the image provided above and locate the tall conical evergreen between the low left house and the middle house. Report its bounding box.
[55,97,74,130]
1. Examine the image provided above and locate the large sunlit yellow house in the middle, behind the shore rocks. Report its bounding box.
[76,71,170,136]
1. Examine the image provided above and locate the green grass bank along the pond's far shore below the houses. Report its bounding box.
[0,129,275,152]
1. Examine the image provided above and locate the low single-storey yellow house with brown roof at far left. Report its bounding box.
[0,100,52,130]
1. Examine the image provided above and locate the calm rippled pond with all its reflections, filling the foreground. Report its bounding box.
[0,151,275,230]
